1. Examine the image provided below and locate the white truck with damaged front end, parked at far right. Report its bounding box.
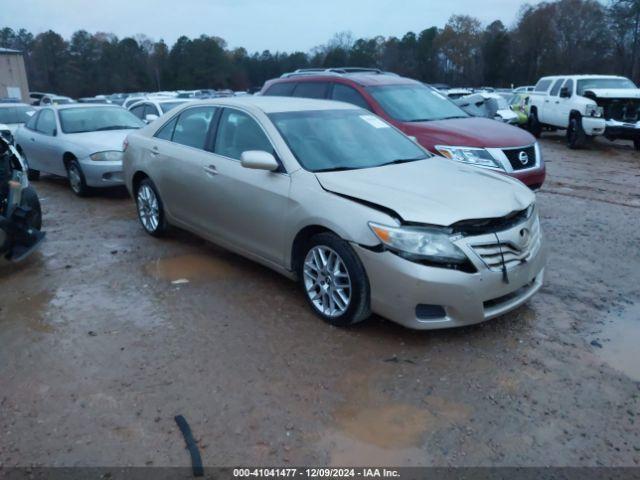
[529,75,640,150]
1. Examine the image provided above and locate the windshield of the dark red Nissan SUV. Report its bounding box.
[368,84,468,122]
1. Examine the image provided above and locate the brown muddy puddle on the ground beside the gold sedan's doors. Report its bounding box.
[145,253,242,284]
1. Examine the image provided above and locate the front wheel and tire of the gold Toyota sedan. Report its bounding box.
[298,233,371,327]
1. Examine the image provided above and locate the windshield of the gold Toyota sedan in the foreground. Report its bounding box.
[270,110,428,172]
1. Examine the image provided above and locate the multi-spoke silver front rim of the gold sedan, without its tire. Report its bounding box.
[303,245,352,318]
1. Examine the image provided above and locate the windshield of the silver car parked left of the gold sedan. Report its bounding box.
[60,107,144,133]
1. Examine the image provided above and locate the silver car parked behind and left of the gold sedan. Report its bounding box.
[15,104,144,196]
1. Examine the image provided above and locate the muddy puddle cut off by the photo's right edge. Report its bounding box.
[592,304,640,381]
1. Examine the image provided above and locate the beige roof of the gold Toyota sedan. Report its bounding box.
[188,95,359,114]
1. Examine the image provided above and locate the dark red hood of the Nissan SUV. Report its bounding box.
[401,117,535,151]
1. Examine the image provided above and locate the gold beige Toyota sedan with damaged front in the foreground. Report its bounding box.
[124,97,545,329]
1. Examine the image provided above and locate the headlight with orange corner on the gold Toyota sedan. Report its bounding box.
[369,222,467,264]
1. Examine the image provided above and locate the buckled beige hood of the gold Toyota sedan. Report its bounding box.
[315,157,535,226]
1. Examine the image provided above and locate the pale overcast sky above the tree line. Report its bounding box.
[0,0,541,52]
